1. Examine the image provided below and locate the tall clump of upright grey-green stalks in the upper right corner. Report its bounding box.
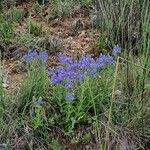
[97,0,150,53]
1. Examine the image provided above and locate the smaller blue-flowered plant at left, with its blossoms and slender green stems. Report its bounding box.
[18,51,49,112]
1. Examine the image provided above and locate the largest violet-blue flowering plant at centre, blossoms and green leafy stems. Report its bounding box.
[48,54,115,131]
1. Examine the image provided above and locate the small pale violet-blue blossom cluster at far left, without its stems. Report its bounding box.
[22,50,48,63]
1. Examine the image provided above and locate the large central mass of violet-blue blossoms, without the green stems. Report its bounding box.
[49,54,115,102]
